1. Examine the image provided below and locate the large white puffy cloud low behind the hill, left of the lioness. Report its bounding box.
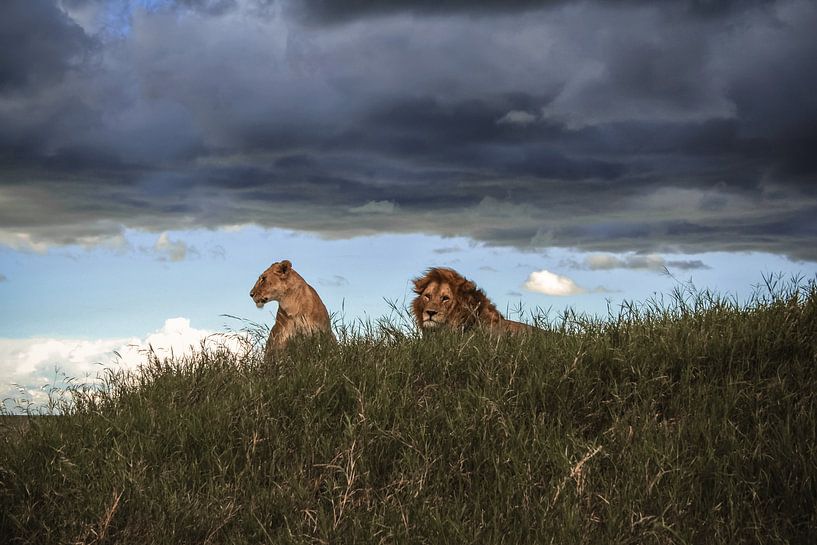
[0,318,247,408]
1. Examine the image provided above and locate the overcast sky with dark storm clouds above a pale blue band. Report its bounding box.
[0,0,817,408]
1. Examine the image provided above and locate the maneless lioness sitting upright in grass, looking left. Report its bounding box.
[250,259,335,361]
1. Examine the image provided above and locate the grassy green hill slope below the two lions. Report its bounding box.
[0,283,817,544]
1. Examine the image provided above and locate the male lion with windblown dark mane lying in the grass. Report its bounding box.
[411,267,536,334]
